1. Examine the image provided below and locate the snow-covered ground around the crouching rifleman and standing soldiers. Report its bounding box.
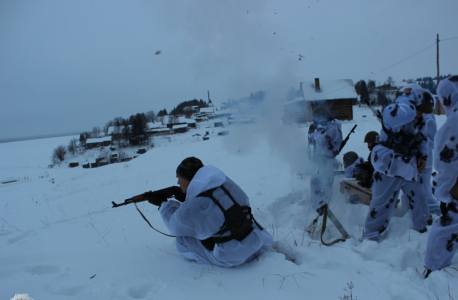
[0,106,458,300]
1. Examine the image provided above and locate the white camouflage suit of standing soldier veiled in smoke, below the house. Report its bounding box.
[308,119,342,209]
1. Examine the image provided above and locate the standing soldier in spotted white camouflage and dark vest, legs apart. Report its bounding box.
[363,88,433,241]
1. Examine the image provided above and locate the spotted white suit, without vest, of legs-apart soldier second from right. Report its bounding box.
[363,90,430,240]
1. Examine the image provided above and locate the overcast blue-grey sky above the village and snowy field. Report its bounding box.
[0,0,458,139]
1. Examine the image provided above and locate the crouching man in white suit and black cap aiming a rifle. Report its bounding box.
[113,157,273,267]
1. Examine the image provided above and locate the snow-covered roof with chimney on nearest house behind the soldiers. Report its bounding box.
[300,79,357,103]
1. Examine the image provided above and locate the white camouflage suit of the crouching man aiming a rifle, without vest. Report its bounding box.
[159,165,273,267]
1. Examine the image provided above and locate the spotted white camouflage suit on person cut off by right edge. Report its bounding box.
[425,76,458,271]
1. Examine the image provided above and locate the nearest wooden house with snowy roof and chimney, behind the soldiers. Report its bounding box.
[283,78,358,124]
